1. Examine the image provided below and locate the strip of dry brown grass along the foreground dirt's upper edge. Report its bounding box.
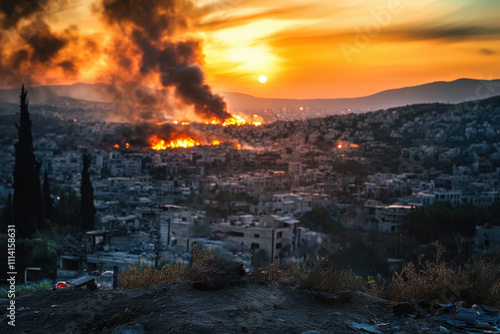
[120,243,500,308]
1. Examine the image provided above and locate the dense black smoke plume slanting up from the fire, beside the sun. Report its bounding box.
[102,0,231,120]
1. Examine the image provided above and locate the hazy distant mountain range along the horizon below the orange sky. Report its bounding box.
[0,79,500,112]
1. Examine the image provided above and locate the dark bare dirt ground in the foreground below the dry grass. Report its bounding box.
[0,279,446,334]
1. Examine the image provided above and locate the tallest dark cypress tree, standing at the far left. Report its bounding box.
[12,85,45,238]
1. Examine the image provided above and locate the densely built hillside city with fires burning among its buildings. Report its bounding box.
[0,92,500,277]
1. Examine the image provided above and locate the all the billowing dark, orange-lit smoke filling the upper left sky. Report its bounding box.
[0,0,230,121]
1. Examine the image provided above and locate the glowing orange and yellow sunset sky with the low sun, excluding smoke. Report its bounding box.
[2,0,500,98]
